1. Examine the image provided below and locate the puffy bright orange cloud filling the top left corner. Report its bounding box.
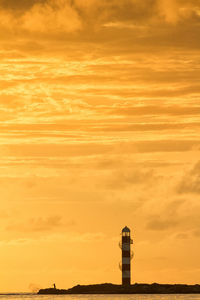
[0,0,81,35]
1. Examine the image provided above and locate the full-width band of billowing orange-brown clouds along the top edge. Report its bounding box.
[0,0,200,36]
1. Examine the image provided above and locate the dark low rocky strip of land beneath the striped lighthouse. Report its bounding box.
[38,283,200,295]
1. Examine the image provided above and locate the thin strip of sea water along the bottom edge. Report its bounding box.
[0,294,200,300]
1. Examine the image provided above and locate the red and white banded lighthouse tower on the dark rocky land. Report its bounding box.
[121,226,133,285]
